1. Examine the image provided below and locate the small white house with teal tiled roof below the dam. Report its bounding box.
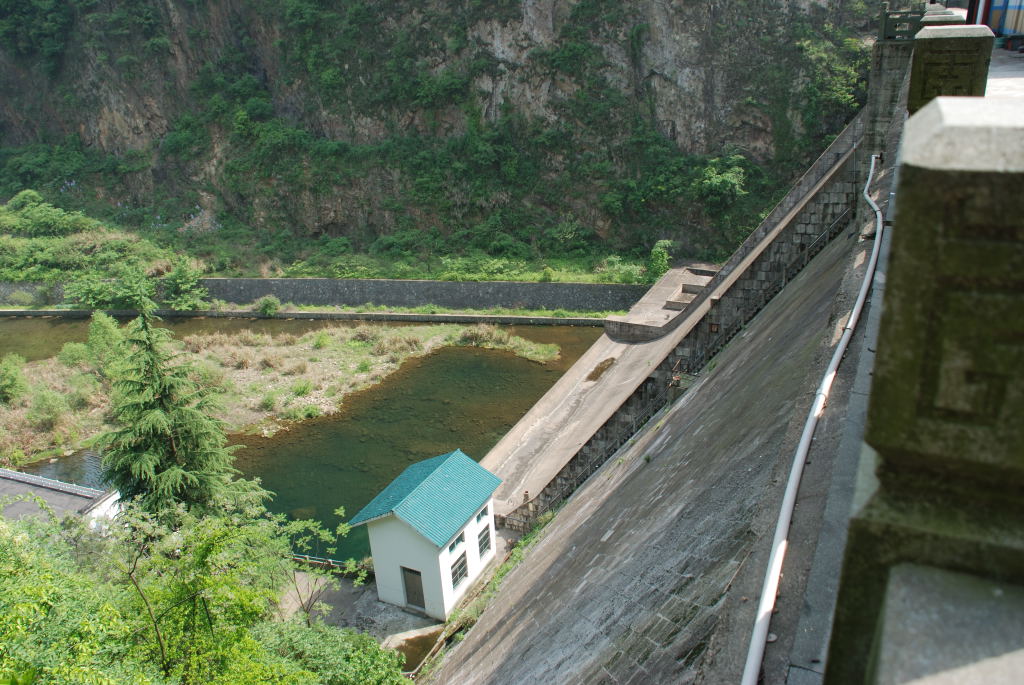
[350,449,502,620]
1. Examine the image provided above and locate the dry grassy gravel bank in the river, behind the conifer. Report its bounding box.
[0,324,559,464]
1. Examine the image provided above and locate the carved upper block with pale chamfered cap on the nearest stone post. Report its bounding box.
[866,97,1024,486]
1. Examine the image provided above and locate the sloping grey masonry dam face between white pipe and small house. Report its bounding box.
[435,233,864,685]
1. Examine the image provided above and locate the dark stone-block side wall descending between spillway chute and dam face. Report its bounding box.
[499,114,863,531]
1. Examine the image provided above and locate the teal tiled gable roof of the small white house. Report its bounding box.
[349,449,502,547]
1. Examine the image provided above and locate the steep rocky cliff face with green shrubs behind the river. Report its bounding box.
[0,0,859,259]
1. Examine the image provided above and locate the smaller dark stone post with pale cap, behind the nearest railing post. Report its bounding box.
[906,26,995,114]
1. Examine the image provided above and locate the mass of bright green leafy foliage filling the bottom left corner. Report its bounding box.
[0,500,403,685]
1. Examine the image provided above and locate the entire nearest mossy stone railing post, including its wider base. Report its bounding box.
[825,97,1024,683]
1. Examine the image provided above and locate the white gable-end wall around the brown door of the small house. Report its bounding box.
[367,515,452,620]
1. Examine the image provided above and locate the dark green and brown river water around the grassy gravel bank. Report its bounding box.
[9,318,601,558]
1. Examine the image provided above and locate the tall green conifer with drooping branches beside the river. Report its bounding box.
[103,301,245,513]
